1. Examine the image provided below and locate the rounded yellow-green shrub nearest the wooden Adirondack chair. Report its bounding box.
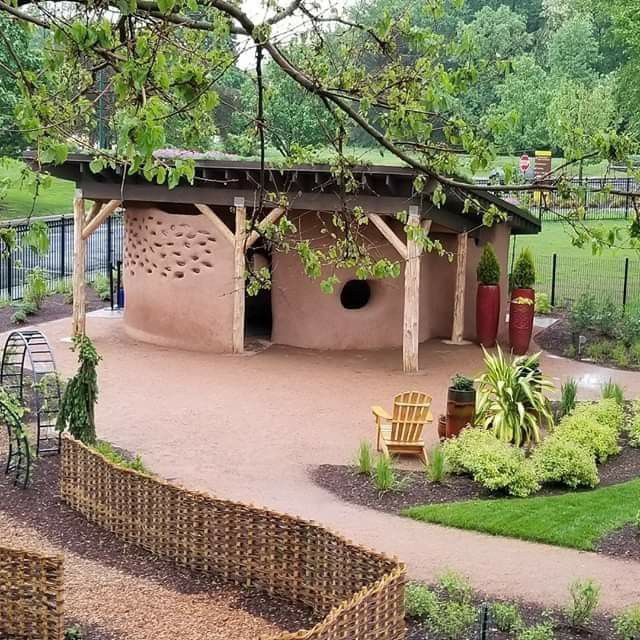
[443,428,540,497]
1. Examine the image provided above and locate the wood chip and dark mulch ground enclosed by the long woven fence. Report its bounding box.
[0,456,315,640]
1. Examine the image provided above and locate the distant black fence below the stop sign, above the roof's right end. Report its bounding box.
[476,177,640,221]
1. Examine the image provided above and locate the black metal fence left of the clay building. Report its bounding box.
[0,215,124,300]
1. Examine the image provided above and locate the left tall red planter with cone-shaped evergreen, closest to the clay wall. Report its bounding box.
[476,243,500,347]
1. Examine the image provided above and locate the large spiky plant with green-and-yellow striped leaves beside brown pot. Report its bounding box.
[476,347,553,447]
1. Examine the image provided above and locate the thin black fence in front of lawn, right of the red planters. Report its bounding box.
[524,253,640,307]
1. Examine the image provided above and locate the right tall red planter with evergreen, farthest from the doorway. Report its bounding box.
[509,249,536,355]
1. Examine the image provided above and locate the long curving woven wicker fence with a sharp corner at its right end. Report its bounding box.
[60,436,405,640]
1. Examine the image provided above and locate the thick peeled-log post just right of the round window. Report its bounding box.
[402,206,422,373]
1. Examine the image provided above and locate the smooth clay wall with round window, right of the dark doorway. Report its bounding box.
[272,214,510,349]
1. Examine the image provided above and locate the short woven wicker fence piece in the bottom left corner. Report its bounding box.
[0,547,64,640]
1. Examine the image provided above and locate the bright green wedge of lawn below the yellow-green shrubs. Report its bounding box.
[403,479,640,551]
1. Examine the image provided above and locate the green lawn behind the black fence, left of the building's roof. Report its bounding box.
[0,158,75,220]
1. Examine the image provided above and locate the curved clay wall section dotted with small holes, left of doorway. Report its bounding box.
[123,204,233,352]
